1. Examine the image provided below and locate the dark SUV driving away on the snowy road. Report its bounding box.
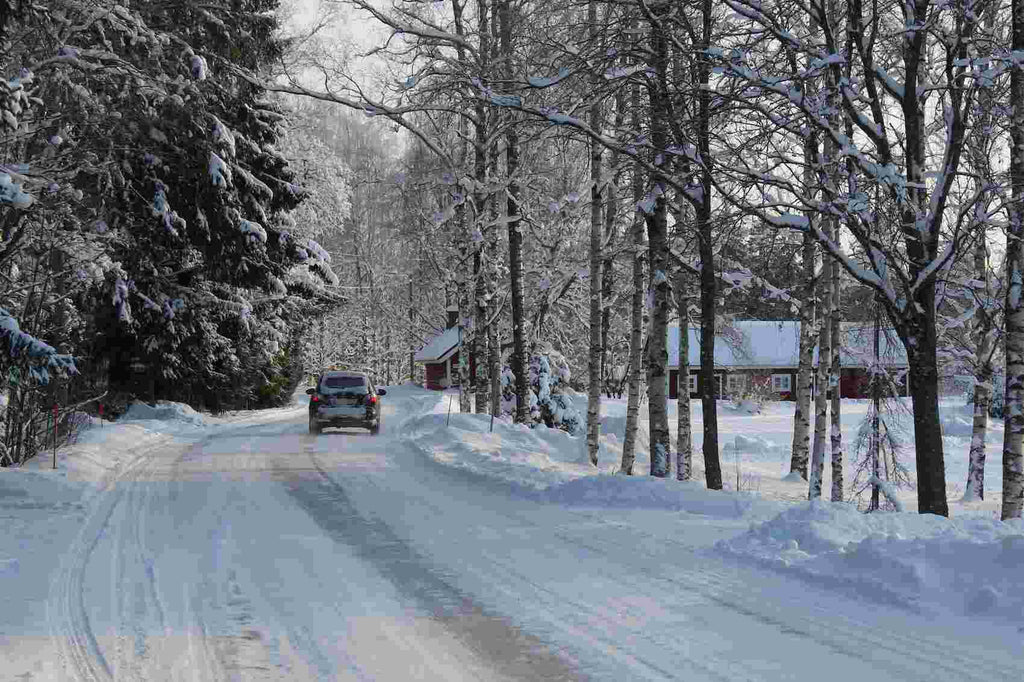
[306,370,387,434]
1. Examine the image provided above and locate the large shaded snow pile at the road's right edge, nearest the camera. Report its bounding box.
[715,501,1024,624]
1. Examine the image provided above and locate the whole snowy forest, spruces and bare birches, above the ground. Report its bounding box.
[0,0,1024,518]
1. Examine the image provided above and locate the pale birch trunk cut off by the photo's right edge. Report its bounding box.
[1001,0,1024,520]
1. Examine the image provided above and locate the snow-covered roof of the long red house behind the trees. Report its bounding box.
[668,319,906,368]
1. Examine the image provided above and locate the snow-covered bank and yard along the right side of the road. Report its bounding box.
[389,387,1024,625]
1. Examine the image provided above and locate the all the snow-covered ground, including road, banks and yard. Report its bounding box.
[0,386,1024,680]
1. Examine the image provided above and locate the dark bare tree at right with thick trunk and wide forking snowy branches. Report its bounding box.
[719,0,995,515]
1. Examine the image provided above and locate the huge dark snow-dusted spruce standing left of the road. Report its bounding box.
[68,2,336,409]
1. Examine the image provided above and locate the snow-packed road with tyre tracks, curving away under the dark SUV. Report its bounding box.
[36,400,1024,682]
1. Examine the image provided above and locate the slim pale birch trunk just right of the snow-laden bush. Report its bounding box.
[587,0,604,466]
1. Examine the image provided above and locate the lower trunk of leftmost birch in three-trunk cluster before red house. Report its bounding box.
[790,231,817,480]
